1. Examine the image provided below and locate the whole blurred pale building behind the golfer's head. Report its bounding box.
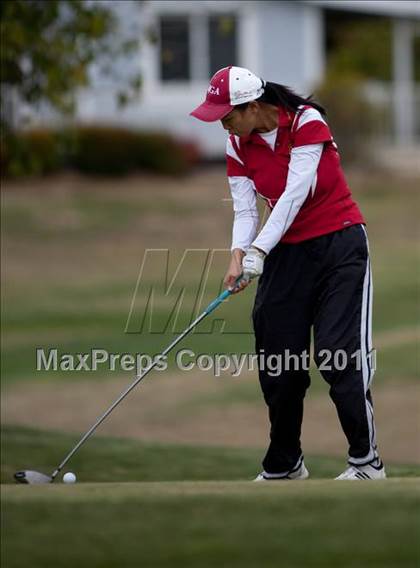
[6,0,420,157]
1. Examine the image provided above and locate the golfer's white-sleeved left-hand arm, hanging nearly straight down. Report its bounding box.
[228,176,259,253]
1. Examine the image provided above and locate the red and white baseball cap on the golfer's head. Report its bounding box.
[190,65,264,122]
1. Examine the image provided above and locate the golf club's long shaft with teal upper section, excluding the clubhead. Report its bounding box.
[51,275,246,481]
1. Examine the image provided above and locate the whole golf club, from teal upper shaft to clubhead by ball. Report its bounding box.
[14,275,248,485]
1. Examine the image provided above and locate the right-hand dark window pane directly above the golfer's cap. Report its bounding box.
[209,14,237,77]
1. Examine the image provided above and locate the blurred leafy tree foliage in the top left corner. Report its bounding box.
[0,0,140,127]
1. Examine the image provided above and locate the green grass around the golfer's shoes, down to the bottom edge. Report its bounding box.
[2,427,420,568]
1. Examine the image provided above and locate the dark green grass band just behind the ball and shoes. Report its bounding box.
[1,426,420,483]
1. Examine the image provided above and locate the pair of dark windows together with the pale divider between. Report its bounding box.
[159,14,238,82]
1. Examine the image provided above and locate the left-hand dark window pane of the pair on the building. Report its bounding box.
[160,16,191,81]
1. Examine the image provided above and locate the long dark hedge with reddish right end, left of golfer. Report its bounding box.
[0,125,200,177]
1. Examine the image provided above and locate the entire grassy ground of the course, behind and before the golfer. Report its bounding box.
[1,173,420,568]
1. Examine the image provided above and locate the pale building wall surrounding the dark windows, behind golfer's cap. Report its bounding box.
[72,0,323,157]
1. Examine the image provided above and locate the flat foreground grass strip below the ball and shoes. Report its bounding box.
[2,478,420,568]
